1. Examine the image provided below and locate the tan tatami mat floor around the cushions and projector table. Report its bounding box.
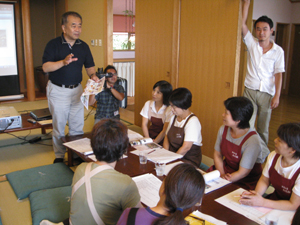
[0,100,141,225]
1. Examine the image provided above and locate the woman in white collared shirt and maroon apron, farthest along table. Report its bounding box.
[140,80,173,145]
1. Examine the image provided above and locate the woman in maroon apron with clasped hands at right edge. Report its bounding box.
[239,123,300,210]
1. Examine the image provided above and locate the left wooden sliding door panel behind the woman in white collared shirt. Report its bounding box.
[135,0,175,125]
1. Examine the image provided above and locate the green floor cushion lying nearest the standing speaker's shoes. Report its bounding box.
[6,163,74,200]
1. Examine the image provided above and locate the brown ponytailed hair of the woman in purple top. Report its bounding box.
[153,163,205,225]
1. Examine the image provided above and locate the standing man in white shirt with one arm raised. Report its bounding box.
[242,0,285,145]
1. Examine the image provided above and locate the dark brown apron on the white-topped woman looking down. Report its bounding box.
[167,114,202,167]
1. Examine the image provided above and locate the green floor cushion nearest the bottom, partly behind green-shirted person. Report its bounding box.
[29,186,72,225]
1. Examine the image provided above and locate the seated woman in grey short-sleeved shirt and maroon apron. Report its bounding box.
[208,97,269,190]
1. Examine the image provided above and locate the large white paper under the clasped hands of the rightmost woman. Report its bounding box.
[215,188,295,225]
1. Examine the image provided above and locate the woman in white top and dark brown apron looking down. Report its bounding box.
[163,88,202,167]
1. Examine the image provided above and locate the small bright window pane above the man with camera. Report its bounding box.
[113,32,135,50]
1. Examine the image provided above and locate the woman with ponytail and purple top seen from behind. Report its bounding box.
[117,163,205,225]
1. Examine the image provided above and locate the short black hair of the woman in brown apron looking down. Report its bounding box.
[169,88,192,109]
